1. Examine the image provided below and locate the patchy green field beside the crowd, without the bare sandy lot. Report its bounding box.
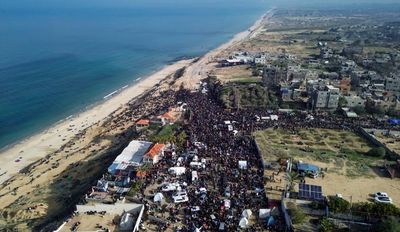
[254,129,383,176]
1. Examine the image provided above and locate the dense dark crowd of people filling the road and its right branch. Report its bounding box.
[134,78,398,231]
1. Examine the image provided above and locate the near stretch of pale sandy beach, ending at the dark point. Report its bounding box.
[0,60,191,183]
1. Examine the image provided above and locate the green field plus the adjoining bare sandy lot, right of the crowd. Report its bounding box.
[255,129,400,206]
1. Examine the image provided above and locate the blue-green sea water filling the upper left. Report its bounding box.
[0,0,270,148]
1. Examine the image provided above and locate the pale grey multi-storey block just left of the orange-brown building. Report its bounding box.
[311,85,339,110]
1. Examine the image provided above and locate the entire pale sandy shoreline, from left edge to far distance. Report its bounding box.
[0,8,274,184]
